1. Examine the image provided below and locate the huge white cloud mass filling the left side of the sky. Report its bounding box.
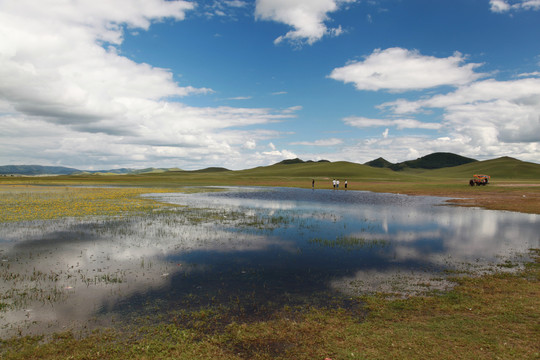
[0,0,299,167]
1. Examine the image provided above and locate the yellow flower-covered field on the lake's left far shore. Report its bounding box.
[0,185,178,222]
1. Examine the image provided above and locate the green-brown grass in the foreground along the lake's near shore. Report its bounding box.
[0,250,540,360]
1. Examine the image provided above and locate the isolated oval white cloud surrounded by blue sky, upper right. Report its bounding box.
[329,48,482,91]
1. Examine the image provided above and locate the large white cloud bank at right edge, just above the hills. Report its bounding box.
[381,78,540,161]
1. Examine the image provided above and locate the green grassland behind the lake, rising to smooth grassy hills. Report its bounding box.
[0,157,540,214]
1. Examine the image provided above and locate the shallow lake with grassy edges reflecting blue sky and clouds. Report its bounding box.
[0,188,540,337]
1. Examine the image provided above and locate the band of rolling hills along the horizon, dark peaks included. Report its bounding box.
[0,153,540,181]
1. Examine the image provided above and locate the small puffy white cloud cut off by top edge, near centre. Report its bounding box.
[255,0,356,45]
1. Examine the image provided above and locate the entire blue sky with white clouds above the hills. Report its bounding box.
[0,0,540,170]
